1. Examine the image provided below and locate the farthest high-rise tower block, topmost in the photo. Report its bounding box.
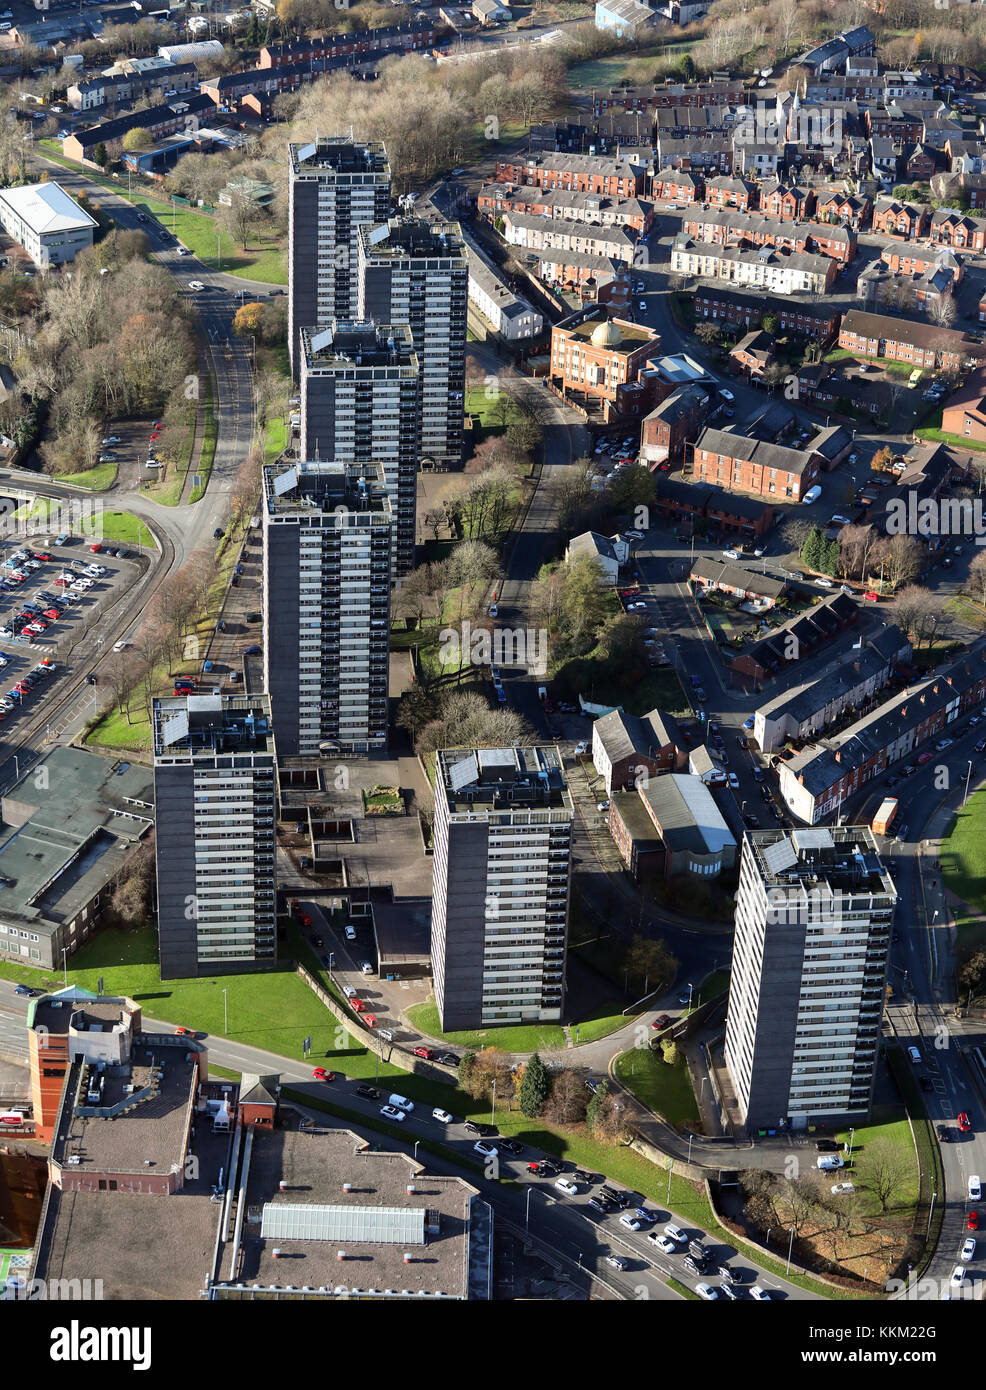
[288,138,391,377]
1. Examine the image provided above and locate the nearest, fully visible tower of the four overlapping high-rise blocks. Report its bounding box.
[263,461,394,758]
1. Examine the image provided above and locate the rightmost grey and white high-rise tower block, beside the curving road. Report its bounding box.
[726,826,897,1129]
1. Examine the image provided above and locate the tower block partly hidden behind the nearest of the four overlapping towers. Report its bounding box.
[300,321,420,580]
